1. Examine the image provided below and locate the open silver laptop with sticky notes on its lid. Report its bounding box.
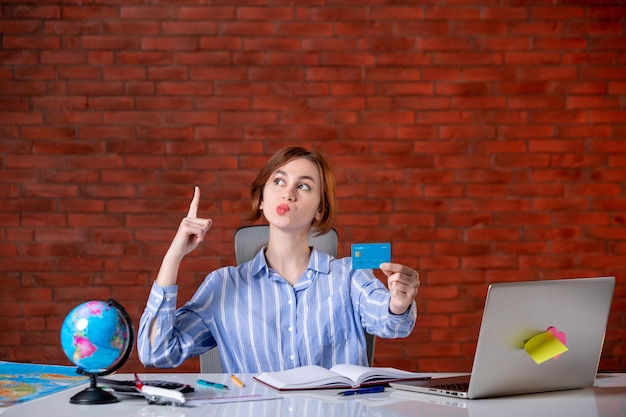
[390,277,615,399]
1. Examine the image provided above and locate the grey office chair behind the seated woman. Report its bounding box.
[200,225,376,373]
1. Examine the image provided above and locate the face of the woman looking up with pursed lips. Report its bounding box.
[261,158,322,231]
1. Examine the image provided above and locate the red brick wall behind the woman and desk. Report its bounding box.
[0,0,626,372]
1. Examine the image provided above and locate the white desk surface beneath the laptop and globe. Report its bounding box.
[0,373,626,417]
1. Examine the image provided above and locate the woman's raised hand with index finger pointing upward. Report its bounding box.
[168,186,213,260]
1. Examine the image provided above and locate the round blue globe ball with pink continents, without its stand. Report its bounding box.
[61,301,129,373]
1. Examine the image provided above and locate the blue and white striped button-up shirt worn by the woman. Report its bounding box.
[137,249,417,373]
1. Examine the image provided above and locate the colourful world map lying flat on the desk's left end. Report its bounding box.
[0,361,89,407]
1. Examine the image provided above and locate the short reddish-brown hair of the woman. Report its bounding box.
[246,146,336,236]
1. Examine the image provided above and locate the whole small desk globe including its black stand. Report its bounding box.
[61,299,135,404]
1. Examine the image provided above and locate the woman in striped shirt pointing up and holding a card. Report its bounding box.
[137,147,419,373]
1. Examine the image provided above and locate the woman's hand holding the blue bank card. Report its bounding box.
[380,263,420,314]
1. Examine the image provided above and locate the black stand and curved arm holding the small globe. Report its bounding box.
[62,298,135,405]
